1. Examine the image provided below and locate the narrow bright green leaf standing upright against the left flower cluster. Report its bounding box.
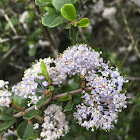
[40,61,50,83]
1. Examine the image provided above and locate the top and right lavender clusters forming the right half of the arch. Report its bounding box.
[57,44,128,130]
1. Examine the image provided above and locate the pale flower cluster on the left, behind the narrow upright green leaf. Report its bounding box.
[12,58,66,105]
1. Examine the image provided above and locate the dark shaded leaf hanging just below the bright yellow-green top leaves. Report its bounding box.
[69,26,78,42]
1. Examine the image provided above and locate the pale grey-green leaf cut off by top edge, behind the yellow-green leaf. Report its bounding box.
[52,0,72,11]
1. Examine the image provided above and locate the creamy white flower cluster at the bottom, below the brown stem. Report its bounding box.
[41,104,69,140]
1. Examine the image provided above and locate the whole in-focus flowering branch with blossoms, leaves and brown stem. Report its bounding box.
[0,44,128,140]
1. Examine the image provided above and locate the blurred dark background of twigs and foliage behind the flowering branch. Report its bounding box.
[0,0,140,140]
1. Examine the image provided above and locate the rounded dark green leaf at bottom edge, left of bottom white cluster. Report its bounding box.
[17,120,34,140]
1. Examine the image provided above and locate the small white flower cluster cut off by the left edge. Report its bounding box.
[0,80,11,107]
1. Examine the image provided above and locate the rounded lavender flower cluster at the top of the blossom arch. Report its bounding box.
[56,44,103,76]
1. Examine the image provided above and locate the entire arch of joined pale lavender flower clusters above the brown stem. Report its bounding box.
[12,44,128,132]
